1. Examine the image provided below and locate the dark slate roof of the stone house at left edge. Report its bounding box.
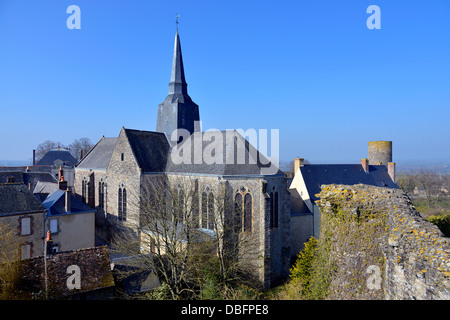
[0,183,45,216]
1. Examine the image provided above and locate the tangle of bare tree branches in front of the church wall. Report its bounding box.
[113,175,258,299]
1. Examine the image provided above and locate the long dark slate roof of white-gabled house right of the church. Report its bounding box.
[300,164,398,202]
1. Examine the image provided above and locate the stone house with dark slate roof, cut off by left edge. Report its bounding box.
[0,181,47,259]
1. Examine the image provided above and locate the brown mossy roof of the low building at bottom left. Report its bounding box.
[15,246,115,300]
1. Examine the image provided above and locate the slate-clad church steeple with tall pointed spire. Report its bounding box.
[156,30,200,142]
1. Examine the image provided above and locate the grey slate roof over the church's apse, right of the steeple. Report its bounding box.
[166,130,283,175]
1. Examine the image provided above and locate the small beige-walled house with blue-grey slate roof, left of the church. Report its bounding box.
[42,182,96,253]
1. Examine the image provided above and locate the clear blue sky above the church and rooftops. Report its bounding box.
[0,0,450,163]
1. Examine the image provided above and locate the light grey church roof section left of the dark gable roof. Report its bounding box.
[76,137,117,169]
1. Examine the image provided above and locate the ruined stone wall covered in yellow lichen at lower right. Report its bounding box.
[317,185,450,299]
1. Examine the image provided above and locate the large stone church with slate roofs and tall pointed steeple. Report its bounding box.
[74,30,292,288]
